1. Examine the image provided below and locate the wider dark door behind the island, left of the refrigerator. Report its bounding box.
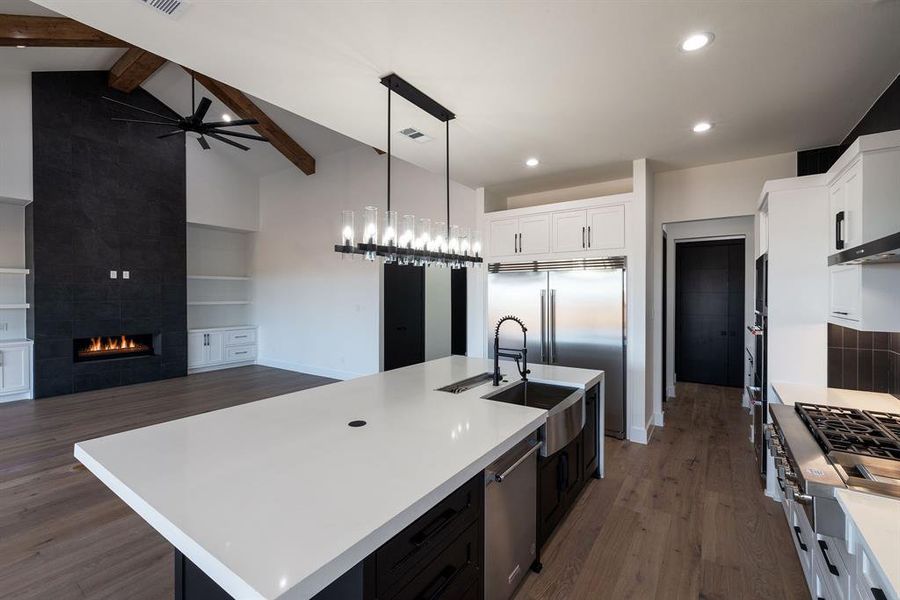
[384,265,425,371]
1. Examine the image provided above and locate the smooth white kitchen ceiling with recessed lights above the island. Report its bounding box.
[24,0,900,191]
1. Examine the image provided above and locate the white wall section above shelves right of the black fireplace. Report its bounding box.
[185,143,259,231]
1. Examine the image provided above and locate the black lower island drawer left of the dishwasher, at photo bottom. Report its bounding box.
[390,521,482,600]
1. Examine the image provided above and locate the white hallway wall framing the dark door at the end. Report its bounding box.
[665,216,756,397]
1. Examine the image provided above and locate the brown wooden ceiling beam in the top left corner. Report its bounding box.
[0,14,128,48]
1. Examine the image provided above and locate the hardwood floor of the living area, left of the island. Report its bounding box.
[0,367,332,600]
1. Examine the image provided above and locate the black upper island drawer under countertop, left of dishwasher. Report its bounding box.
[375,474,484,596]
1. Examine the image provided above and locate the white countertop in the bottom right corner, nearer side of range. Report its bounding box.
[835,490,900,598]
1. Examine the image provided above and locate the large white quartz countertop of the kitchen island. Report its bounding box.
[75,356,603,600]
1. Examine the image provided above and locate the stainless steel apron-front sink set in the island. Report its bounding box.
[482,381,585,456]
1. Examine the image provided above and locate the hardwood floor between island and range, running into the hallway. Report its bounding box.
[515,384,809,600]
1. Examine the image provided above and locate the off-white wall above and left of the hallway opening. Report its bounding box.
[650,152,797,424]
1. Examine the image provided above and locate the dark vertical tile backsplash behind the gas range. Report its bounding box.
[828,323,900,398]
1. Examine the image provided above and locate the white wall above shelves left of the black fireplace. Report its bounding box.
[0,69,34,201]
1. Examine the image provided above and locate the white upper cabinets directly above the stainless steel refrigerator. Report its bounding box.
[487,194,631,260]
